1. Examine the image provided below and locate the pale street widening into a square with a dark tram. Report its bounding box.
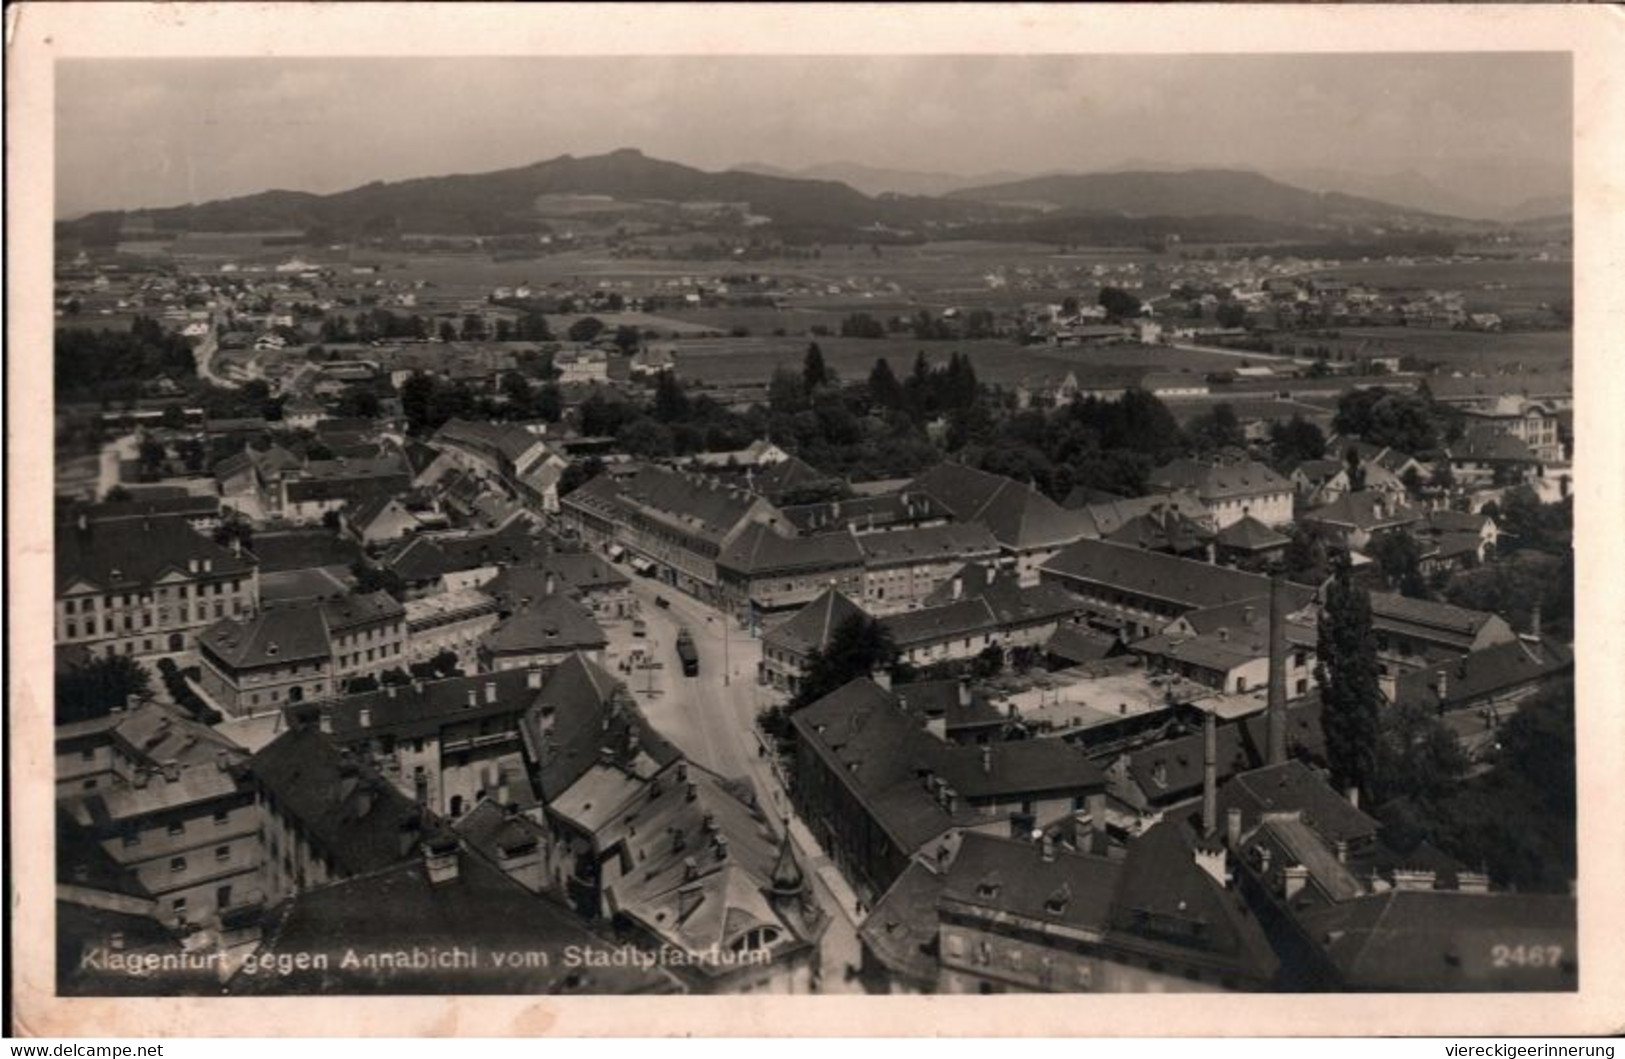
[606,577,861,992]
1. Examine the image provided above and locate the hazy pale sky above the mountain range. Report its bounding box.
[55,52,1571,218]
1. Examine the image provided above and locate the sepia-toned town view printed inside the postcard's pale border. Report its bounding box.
[8,5,1619,1031]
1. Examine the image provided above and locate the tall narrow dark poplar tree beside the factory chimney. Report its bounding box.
[1315,552,1383,794]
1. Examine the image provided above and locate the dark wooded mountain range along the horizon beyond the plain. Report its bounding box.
[59,149,1555,248]
